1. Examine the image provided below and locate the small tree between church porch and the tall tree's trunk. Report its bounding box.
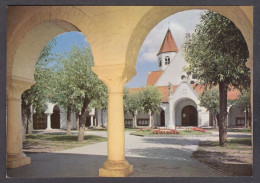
[199,88,219,128]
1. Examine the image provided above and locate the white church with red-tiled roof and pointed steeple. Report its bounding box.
[37,29,249,129]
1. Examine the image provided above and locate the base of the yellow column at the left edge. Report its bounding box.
[6,153,31,168]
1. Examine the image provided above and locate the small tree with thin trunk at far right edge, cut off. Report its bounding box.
[235,89,252,128]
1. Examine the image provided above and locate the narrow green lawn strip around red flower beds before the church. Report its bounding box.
[130,129,211,136]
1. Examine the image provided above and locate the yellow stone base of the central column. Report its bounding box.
[99,160,133,177]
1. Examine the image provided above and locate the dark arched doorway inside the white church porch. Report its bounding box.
[181,105,198,126]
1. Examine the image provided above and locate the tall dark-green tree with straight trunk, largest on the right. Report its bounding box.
[184,11,250,146]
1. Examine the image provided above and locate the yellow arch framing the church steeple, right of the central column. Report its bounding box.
[126,6,253,69]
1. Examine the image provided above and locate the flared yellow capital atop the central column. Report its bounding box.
[92,64,136,94]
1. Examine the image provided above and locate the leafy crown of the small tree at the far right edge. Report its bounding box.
[234,90,251,111]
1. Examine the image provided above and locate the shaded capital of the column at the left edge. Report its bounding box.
[6,76,35,100]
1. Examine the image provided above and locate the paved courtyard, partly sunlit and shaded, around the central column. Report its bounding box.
[7,131,248,178]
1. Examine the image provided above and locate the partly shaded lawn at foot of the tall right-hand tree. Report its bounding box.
[192,138,253,176]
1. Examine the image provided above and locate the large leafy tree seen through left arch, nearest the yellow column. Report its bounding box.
[52,45,107,141]
